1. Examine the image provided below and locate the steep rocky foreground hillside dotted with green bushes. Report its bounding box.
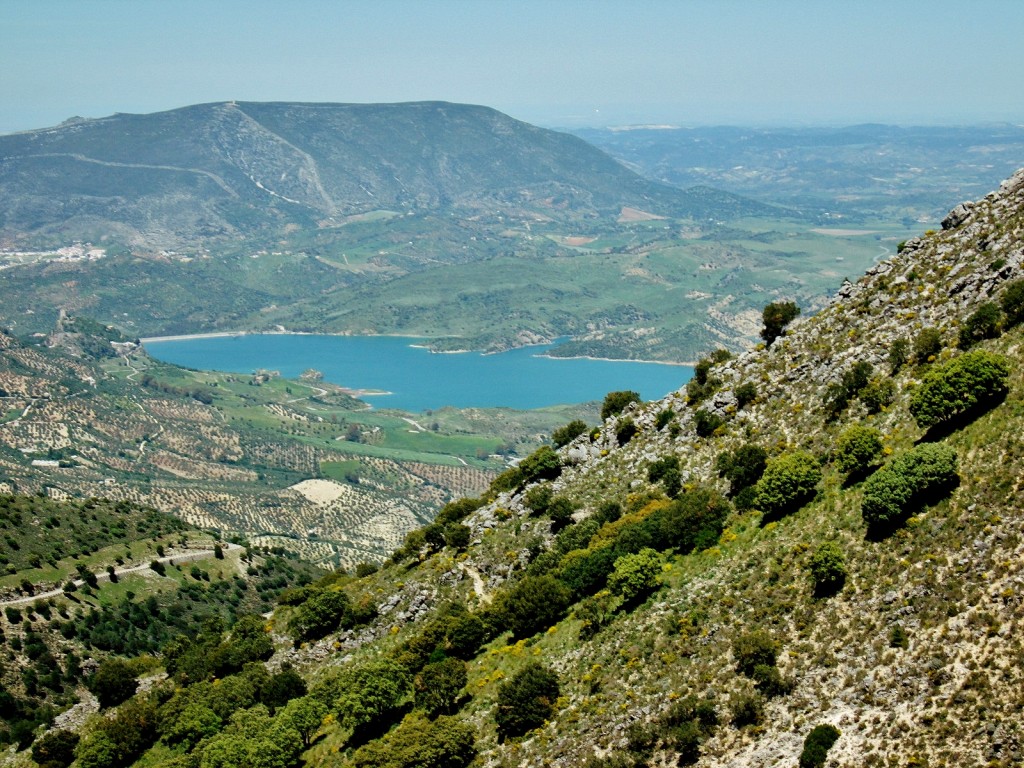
[4,170,1024,768]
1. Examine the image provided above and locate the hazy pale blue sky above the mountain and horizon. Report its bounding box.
[0,0,1024,132]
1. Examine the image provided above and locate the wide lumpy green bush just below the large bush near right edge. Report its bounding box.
[860,443,958,526]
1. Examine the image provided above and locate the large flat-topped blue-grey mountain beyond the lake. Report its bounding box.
[0,101,767,250]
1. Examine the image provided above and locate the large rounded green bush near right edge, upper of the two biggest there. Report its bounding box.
[909,350,1010,427]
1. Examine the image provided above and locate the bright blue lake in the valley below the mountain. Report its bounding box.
[145,334,693,412]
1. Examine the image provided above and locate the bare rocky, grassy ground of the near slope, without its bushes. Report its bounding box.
[294,171,1024,767]
